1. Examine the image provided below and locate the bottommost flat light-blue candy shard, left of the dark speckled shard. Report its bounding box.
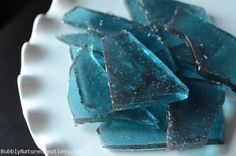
[97,121,166,150]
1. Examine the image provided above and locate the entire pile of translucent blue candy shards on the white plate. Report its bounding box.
[58,3,227,150]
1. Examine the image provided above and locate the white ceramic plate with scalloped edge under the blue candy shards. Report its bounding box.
[18,0,236,156]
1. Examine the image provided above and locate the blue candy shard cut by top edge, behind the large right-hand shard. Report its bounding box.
[126,0,210,48]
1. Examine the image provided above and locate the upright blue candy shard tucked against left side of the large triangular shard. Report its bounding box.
[72,48,111,112]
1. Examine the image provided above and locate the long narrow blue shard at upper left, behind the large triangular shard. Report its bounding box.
[64,6,177,71]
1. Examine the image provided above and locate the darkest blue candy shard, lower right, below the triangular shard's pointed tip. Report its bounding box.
[167,79,225,149]
